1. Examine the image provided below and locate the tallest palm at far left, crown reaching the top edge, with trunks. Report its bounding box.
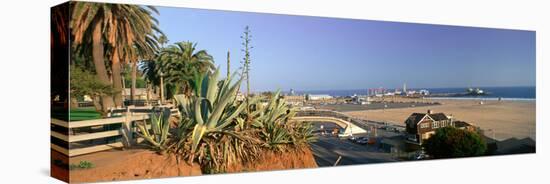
[71,2,161,110]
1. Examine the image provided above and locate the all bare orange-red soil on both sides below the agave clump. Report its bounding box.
[64,148,318,183]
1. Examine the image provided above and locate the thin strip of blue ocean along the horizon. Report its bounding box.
[296,86,536,100]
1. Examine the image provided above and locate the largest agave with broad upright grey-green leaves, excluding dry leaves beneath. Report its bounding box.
[176,70,256,166]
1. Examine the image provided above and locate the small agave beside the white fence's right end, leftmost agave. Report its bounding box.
[137,109,170,151]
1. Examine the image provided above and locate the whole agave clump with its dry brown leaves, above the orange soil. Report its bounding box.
[175,70,311,173]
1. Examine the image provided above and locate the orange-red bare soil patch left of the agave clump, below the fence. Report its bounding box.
[70,149,201,183]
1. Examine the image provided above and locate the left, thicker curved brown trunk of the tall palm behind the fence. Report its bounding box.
[92,24,113,113]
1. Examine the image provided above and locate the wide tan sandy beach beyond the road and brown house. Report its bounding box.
[344,100,536,140]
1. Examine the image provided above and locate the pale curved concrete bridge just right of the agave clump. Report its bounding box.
[291,110,367,137]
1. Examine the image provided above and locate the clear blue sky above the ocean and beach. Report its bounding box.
[153,7,535,91]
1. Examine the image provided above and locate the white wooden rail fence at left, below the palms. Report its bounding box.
[51,107,179,157]
